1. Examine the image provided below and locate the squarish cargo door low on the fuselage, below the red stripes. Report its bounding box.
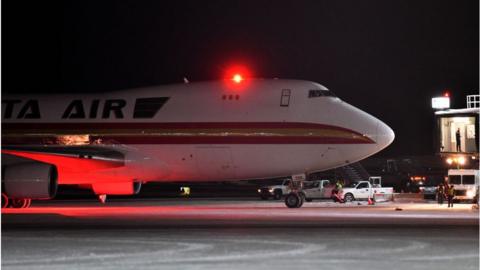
[196,146,235,180]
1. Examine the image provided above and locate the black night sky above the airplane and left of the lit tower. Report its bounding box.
[2,0,479,156]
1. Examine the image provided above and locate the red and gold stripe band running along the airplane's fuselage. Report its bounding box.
[2,122,375,144]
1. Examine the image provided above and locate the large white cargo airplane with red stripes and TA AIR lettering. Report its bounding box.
[2,75,394,208]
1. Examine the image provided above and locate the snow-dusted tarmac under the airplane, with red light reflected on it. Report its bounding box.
[1,198,479,270]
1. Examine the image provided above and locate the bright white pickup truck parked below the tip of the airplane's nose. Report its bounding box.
[342,181,393,202]
